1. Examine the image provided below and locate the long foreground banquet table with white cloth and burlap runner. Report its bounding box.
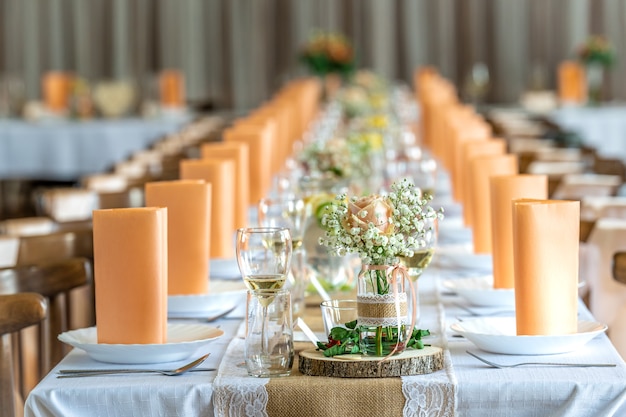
[25,170,626,417]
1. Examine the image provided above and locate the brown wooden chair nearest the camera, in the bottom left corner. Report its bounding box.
[0,293,47,417]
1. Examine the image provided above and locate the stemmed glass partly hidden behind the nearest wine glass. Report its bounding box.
[258,195,308,316]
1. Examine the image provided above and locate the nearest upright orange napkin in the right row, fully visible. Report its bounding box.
[513,199,580,335]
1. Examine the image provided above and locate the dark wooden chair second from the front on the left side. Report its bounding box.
[0,258,93,393]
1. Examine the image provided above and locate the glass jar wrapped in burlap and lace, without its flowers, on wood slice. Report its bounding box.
[357,265,415,356]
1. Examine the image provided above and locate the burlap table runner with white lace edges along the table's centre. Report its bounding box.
[213,288,456,417]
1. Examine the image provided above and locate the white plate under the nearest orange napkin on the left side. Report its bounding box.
[58,323,224,365]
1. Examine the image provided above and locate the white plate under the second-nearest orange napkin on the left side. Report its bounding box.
[167,290,246,318]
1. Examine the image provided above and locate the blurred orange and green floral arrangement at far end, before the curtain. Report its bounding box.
[300,31,356,77]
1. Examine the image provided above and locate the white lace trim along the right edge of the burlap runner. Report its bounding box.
[401,272,457,417]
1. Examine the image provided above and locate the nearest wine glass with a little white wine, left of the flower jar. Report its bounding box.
[236,227,292,374]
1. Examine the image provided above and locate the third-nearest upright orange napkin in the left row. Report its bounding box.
[180,158,235,258]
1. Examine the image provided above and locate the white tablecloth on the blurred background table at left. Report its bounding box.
[0,115,190,181]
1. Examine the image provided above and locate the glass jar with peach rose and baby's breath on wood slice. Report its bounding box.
[320,179,443,356]
